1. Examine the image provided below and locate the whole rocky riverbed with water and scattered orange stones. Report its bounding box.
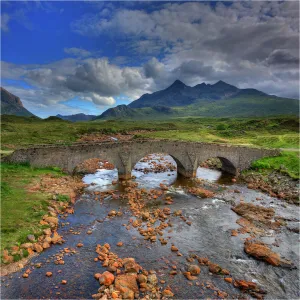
[1,155,300,300]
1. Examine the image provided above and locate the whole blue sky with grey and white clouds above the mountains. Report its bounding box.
[1,1,299,117]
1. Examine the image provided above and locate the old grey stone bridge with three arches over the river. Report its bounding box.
[5,140,280,179]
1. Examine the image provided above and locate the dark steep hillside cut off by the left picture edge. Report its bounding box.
[1,87,34,117]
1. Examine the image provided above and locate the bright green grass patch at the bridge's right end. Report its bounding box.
[251,151,300,179]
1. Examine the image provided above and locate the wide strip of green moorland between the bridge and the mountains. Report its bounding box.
[1,116,299,151]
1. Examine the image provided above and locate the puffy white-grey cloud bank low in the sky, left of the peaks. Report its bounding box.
[1,58,153,111]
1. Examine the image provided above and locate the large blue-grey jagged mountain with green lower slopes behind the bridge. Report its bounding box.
[97,80,299,119]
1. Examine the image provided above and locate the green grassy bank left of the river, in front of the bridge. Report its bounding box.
[1,163,63,255]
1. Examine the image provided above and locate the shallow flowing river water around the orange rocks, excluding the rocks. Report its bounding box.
[1,156,300,299]
